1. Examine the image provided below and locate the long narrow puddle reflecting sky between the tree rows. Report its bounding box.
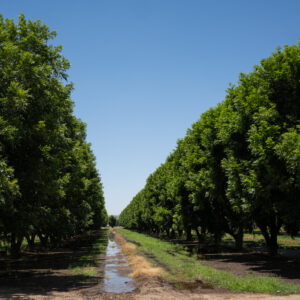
[101,234,135,293]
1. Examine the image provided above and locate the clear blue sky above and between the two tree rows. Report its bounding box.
[0,0,300,214]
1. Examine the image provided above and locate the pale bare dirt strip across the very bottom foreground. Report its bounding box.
[0,276,300,300]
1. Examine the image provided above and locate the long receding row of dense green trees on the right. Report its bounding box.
[119,43,300,253]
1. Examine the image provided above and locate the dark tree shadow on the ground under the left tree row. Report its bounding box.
[0,231,107,299]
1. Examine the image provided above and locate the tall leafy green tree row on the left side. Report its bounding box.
[0,15,107,255]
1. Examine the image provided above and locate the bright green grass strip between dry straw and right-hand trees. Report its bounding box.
[117,229,300,295]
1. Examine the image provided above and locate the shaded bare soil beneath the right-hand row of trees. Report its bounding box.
[176,237,300,284]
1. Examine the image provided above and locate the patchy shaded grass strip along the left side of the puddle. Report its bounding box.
[69,230,108,277]
